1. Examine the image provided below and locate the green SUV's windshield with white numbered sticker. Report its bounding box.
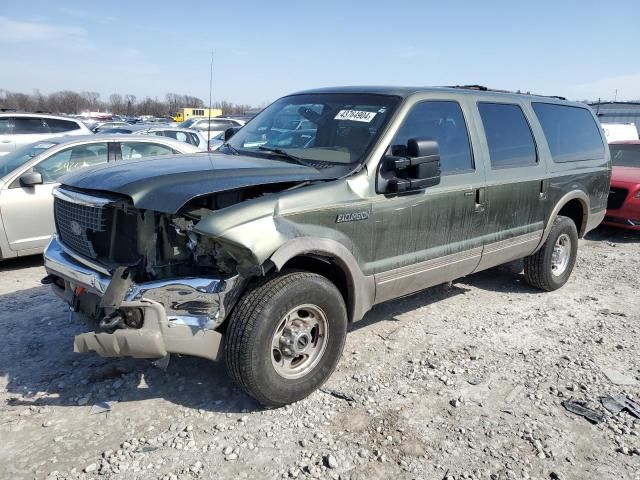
[220,94,400,168]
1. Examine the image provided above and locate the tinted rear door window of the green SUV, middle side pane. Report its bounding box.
[478,103,538,168]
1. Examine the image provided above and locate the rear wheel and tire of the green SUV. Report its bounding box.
[524,216,578,292]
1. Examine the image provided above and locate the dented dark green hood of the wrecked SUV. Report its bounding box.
[61,153,332,213]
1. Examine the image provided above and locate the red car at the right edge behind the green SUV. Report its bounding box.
[602,140,640,230]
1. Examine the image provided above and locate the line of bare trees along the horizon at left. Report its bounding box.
[0,89,253,117]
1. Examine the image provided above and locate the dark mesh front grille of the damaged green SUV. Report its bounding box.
[53,198,113,259]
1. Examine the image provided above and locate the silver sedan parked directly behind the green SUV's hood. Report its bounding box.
[0,135,199,259]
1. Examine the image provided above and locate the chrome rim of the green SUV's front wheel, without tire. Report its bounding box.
[271,304,329,379]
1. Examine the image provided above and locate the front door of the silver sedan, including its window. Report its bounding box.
[0,142,109,254]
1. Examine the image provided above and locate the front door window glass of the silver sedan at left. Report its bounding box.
[33,143,107,183]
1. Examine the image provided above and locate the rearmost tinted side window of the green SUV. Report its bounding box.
[531,103,604,162]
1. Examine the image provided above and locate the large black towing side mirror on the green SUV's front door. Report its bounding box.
[377,138,441,193]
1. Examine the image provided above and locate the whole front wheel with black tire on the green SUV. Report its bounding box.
[224,272,347,407]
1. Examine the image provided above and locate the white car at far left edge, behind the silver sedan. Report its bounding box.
[0,113,91,155]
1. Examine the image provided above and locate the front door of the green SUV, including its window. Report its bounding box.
[372,98,484,302]
